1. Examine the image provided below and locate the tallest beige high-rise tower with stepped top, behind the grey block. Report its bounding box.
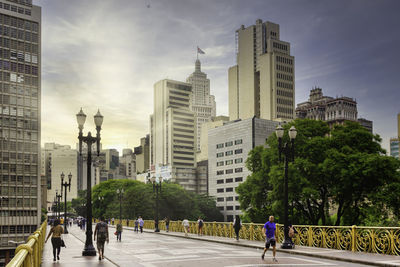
[228,19,295,120]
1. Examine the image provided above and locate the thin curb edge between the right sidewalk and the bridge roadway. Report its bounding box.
[110,225,398,267]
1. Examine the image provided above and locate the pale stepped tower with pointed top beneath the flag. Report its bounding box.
[186,59,216,151]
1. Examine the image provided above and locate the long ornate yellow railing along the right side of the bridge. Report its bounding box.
[136,220,400,256]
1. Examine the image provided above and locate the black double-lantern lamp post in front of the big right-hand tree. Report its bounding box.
[275,125,297,249]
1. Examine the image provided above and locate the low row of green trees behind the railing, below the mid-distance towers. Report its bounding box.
[73,179,223,221]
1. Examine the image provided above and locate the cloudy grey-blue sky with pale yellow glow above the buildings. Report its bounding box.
[37,0,400,154]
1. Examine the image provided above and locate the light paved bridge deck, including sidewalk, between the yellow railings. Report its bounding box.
[42,226,400,267]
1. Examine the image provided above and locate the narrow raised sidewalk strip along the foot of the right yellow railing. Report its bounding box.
[110,225,400,267]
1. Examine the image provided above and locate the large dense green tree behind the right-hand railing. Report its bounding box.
[237,120,400,225]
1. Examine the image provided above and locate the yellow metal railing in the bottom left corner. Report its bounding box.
[6,220,47,267]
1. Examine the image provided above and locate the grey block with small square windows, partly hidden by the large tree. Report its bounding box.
[208,117,278,221]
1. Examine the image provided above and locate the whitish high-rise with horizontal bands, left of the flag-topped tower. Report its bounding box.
[150,80,197,191]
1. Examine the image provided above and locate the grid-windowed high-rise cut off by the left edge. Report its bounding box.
[0,0,41,265]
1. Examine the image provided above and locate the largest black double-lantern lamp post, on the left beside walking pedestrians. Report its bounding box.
[76,108,103,256]
